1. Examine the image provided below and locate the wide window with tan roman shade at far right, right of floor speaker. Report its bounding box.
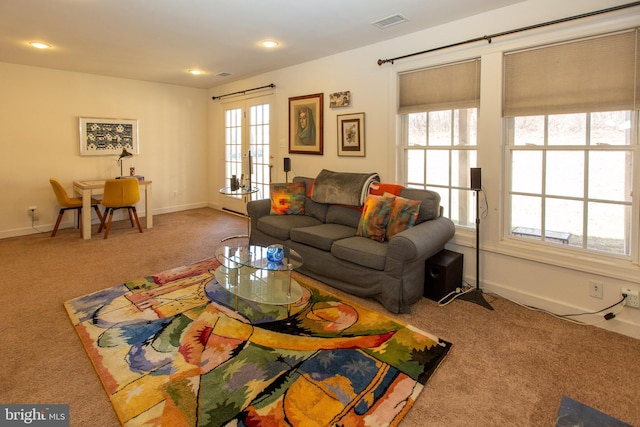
[503,29,640,262]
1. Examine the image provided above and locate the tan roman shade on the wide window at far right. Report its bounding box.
[503,30,640,117]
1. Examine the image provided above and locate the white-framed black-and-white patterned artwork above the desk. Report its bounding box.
[80,117,140,156]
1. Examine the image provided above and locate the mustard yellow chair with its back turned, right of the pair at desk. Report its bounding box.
[98,178,142,239]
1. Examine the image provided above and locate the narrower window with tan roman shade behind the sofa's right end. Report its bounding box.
[398,59,480,231]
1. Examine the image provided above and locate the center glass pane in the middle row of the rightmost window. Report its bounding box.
[546,151,584,197]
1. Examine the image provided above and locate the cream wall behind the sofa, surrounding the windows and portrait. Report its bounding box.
[209,0,640,338]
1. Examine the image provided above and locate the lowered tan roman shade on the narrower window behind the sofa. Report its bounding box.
[398,59,480,114]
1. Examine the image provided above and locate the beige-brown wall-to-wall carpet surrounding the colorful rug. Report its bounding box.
[0,209,640,426]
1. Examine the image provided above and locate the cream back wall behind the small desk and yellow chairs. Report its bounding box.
[0,63,208,237]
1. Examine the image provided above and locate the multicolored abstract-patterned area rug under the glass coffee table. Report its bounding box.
[65,259,451,427]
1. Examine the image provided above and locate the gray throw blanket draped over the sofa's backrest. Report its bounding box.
[311,169,380,206]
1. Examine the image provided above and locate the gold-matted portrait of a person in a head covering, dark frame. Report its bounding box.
[289,93,323,155]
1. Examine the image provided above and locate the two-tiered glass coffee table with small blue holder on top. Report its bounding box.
[215,245,303,305]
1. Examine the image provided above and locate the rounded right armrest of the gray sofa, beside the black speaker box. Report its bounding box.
[387,217,456,261]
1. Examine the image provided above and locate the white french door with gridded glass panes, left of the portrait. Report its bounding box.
[222,95,273,214]
